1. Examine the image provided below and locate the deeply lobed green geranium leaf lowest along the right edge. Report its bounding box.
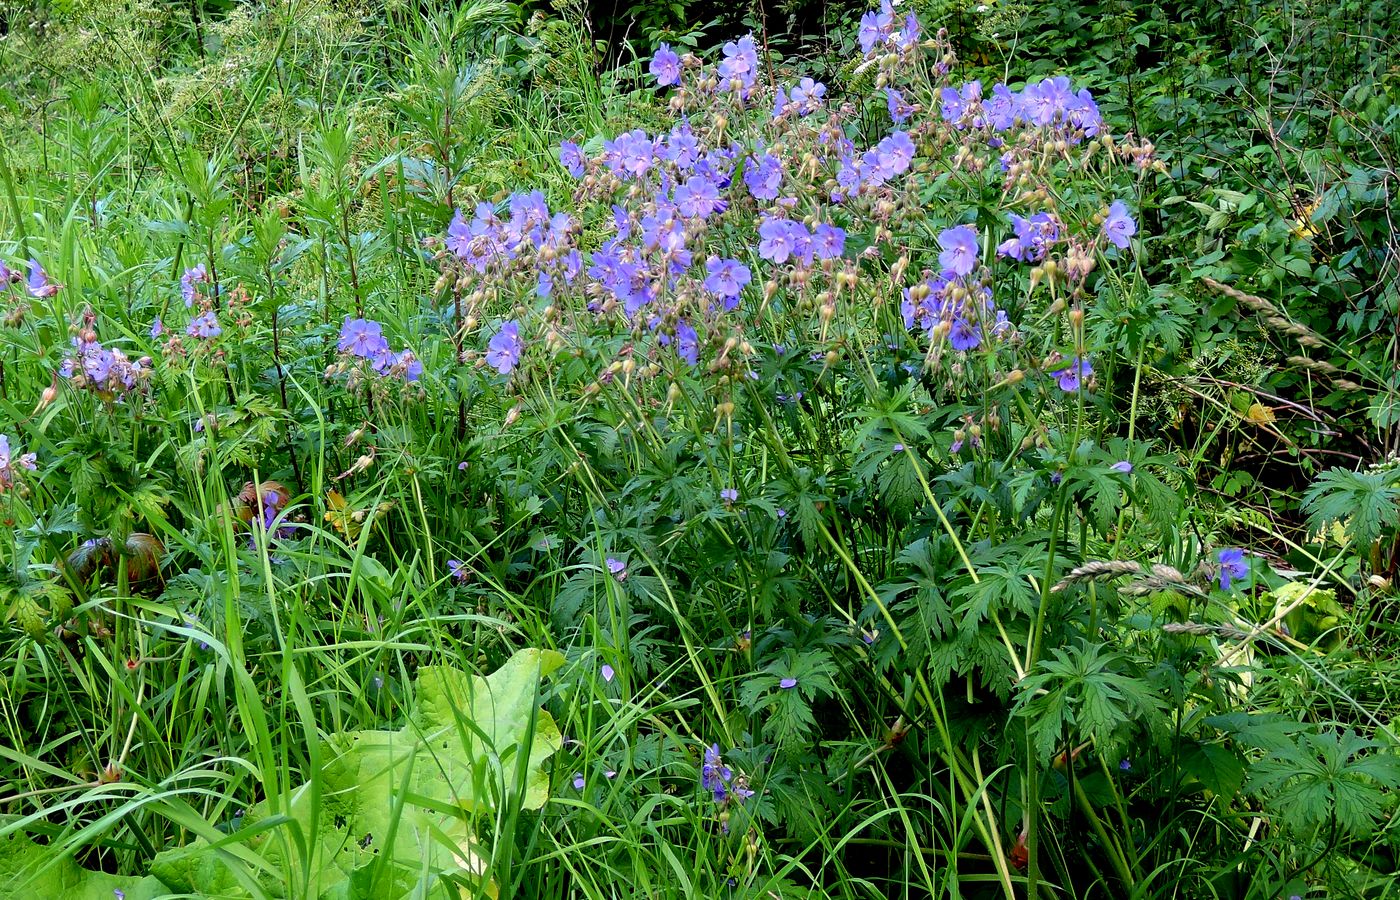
[1249,729,1400,837]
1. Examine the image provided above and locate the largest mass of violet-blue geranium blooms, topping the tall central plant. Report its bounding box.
[425,0,1144,409]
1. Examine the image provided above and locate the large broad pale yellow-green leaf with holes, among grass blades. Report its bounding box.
[151,649,564,900]
